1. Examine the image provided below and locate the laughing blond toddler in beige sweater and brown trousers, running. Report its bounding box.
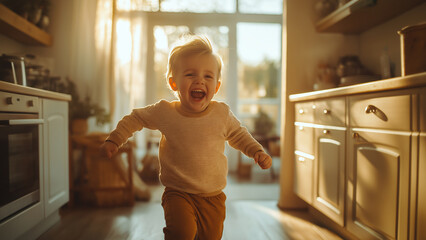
[101,36,272,240]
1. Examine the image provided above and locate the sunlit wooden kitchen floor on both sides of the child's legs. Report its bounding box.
[39,172,341,240]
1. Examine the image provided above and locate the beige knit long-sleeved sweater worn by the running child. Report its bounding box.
[108,100,263,194]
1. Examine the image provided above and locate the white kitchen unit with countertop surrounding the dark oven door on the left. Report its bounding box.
[0,82,71,240]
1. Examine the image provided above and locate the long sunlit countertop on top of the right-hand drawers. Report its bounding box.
[289,72,426,102]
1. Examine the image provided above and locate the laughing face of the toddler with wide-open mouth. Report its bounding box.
[169,54,220,112]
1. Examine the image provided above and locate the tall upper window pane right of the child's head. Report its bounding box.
[237,23,281,99]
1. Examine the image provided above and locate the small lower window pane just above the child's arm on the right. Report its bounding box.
[238,104,280,136]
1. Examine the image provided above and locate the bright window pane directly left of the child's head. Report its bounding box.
[154,26,189,101]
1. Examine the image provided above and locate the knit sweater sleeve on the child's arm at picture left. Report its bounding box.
[106,103,160,147]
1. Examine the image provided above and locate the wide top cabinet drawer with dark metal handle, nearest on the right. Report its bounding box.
[349,92,411,131]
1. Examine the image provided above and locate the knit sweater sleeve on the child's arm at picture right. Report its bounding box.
[225,108,264,158]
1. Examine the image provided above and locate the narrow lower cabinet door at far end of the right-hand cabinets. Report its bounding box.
[294,151,314,204]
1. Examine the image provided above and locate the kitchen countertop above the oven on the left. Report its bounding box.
[0,81,71,101]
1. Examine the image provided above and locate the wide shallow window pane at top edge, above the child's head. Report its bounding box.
[161,0,236,13]
